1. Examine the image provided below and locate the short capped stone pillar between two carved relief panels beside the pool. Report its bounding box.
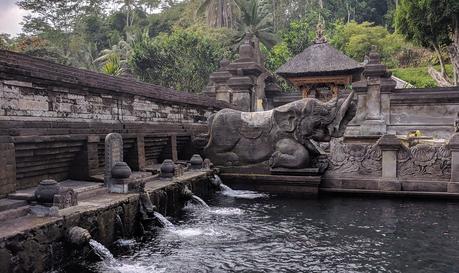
[377,135,402,191]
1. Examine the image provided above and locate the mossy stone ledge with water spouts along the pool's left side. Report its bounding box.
[0,171,214,273]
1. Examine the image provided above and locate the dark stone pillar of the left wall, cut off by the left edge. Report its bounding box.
[0,137,16,198]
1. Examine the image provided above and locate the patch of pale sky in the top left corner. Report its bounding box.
[0,0,27,36]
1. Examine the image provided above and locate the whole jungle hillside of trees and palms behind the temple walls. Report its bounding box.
[0,0,459,92]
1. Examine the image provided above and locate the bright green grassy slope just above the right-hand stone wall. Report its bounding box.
[392,65,453,88]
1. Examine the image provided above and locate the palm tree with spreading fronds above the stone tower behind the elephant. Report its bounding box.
[234,0,278,64]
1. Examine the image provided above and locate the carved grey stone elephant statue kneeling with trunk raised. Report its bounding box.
[204,92,356,169]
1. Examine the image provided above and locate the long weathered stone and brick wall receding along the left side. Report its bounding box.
[0,50,234,197]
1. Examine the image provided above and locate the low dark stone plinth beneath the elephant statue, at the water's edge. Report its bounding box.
[220,173,321,197]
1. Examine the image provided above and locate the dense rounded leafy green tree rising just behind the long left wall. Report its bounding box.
[131,28,229,92]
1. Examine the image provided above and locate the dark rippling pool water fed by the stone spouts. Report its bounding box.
[63,191,459,273]
